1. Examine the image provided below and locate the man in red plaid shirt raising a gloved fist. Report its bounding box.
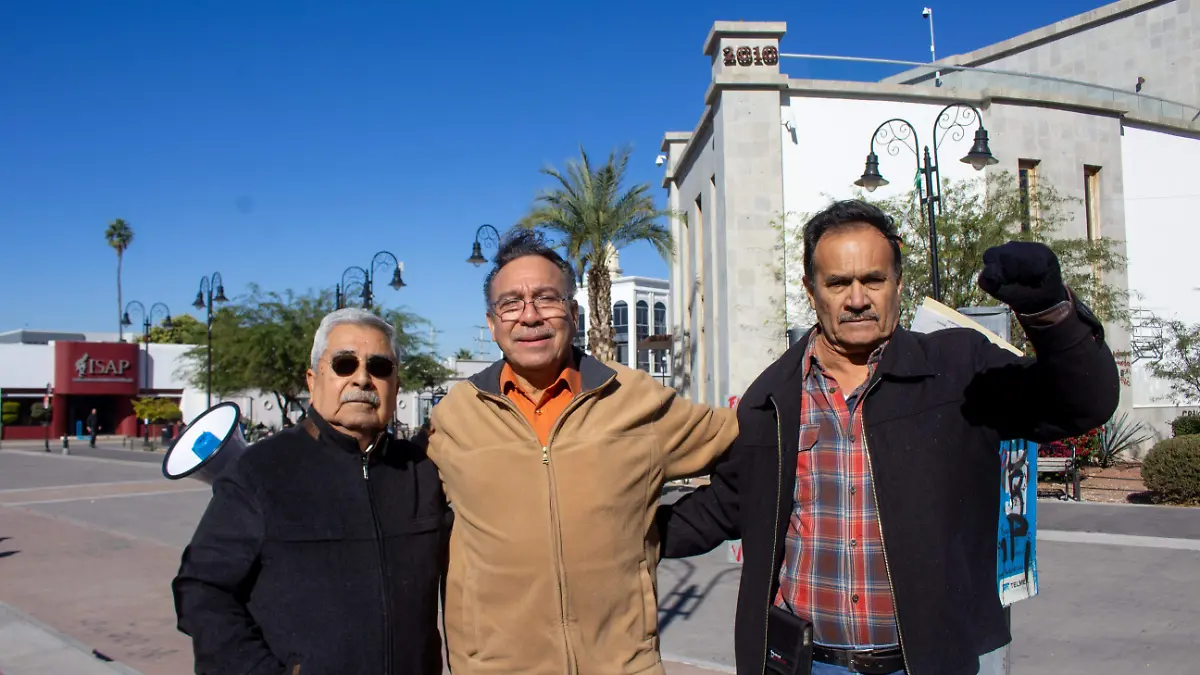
[658,201,1118,675]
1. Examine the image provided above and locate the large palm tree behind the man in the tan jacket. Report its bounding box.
[517,147,674,360]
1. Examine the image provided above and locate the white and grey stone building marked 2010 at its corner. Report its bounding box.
[662,0,1200,434]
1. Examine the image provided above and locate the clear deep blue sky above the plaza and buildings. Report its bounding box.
[0,0,1099,354]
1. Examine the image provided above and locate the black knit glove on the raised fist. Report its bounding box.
[979,241,1068,315]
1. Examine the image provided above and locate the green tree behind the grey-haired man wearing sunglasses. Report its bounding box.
[184,286,426,423]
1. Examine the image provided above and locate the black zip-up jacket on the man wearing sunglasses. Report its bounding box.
[172,411,448,675]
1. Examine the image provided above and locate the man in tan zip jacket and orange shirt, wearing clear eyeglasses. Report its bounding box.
[428,231,737,675]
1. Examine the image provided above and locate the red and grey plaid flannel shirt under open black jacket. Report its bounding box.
[775,340,899,649]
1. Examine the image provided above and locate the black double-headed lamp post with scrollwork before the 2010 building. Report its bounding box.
[854,103,998,301]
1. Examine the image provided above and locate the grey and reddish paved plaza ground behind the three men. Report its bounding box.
[0,441,1200,675]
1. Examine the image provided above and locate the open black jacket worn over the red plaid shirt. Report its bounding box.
[658,297,1120,675]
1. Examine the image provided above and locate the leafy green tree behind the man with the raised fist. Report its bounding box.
[780,171,1129,348]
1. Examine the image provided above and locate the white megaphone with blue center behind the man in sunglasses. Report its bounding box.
[162,401,248,485]
